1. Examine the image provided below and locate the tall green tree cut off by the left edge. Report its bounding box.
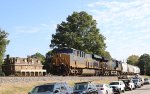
[0,29,9,65]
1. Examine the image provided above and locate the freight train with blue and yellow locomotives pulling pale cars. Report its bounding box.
[51,48,140,76]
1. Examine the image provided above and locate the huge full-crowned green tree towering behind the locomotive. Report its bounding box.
[50,11,110,56]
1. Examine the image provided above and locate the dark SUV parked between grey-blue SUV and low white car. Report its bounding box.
[73,82,98,94]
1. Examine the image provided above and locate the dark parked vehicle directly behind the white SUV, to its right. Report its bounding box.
[122,79,135,90]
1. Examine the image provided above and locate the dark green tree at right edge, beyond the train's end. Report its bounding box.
[137,54,150,75]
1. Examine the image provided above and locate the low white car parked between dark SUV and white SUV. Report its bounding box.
[96,84,113,94]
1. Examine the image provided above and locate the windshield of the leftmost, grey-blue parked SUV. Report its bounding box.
[32,85,54,93]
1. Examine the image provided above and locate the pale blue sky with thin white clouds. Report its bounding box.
[0,0,150,60]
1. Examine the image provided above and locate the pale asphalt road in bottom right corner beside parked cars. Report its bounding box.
[122,85,150,94]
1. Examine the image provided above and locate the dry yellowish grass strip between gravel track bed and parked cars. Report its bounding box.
[0,76,116,94]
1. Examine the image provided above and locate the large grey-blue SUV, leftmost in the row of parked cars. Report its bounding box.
[28,82,73,94]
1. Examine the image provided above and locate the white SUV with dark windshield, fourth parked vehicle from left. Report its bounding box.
[109,81,125,92]
